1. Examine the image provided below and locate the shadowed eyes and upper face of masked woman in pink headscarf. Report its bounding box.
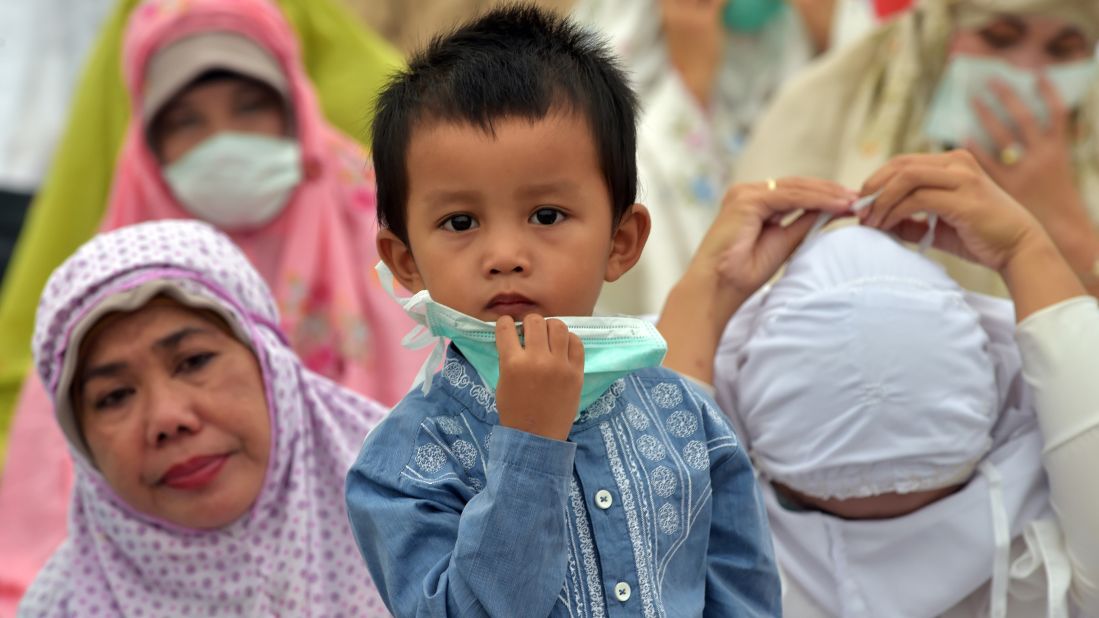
[149,76,289,165]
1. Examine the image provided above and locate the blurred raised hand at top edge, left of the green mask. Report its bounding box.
[660,0,726,103]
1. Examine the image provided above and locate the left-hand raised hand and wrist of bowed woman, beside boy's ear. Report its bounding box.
[657,178,856,383]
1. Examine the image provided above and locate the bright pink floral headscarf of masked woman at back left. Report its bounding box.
[103,0,425,405]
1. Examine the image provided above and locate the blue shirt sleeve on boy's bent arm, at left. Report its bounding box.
[346,427,576,617]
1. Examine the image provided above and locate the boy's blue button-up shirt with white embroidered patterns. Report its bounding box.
[346,346,781,618]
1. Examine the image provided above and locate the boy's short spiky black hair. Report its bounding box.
[371,4,637,244]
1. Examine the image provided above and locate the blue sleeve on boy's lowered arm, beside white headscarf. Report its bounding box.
[703,395,782,617]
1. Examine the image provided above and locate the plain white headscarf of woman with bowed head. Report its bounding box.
[714,227,1048,617]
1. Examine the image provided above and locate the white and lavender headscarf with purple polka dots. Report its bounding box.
[20,221,387,616]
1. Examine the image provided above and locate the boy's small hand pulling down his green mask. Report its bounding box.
[496,313,584,440]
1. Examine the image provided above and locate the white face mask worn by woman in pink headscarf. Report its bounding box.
[164,132,301,231]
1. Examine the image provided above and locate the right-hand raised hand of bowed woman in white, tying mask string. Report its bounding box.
[858,151,1085,320]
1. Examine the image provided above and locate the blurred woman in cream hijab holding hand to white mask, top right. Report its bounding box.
[736,0,1099,296]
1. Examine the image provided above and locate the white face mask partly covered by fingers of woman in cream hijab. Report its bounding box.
[923,55,1097,147]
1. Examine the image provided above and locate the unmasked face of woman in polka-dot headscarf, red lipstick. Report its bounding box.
[71,298,270,529]
